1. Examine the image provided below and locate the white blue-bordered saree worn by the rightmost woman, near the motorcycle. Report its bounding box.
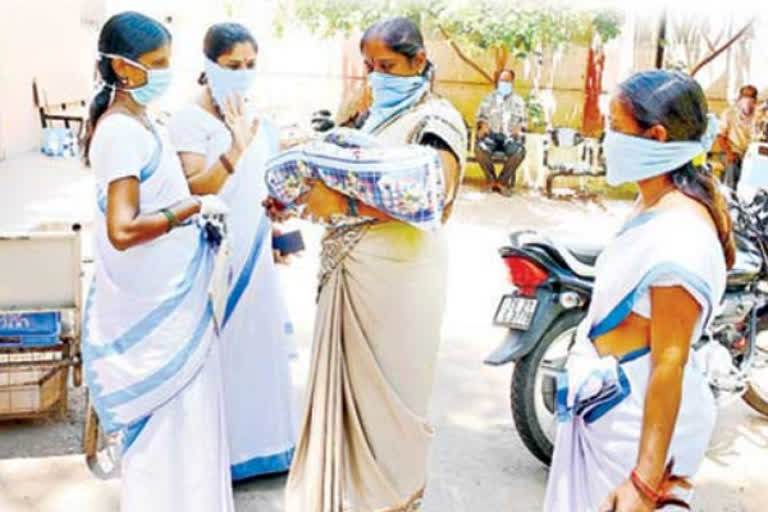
[544,206,726,512]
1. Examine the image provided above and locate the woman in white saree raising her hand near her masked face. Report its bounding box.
[169,23,296,480]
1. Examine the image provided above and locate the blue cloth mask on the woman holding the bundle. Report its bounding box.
[363,71,429,132]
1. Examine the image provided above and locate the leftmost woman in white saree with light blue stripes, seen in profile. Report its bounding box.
[83,12,233,512]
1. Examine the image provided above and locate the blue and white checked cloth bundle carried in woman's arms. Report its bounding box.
[266,128,446,230]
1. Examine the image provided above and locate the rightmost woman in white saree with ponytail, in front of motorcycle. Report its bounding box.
[544,71,735,512]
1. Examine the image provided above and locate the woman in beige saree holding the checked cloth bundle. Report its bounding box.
[278,18,466,512]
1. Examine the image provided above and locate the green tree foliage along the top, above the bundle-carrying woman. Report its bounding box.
[276,0,623,59]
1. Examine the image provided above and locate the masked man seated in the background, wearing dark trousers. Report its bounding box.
[475,69,528,196]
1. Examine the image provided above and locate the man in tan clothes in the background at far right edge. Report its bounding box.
[717,85,757,190]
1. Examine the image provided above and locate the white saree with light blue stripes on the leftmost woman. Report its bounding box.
[83,114,233,512]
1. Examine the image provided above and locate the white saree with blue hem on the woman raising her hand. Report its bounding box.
[170,104,297,481]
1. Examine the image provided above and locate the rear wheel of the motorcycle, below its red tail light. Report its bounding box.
[510,311,585,465]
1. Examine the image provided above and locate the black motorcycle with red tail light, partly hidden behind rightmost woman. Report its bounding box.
[485,187,768,464]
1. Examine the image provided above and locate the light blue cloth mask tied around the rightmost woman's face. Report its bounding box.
[603,114,718,186]
